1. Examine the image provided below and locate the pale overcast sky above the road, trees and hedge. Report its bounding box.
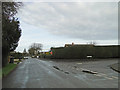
[16,2,118,52]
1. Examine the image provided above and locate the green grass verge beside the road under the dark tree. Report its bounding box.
[0,64,17,78]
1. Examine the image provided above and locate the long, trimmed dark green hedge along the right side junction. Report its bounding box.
[51,45,118,59]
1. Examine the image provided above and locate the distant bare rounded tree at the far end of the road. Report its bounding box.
[28,43,43,55]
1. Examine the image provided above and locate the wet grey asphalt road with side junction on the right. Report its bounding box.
[3,58,118,88]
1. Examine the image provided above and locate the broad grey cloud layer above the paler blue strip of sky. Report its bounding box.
[18,2,118,40]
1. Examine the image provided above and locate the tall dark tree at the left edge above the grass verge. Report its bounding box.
[2,2,22,66]
